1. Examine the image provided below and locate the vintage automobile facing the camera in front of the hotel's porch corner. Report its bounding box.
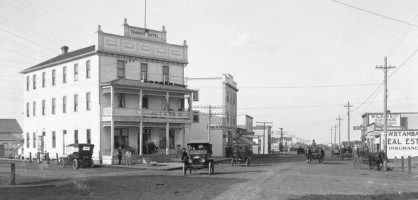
[183,141,215,176]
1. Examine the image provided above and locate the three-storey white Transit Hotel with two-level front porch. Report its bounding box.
[21,19,195,163]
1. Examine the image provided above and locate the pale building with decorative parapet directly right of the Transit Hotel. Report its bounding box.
[186,74,238,156]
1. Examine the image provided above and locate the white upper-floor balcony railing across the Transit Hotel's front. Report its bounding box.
[103,107,191,119]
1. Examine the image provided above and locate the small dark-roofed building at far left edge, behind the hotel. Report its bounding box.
[0,119,24,158]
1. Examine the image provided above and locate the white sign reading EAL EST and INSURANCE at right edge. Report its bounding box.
[387,130,418,158]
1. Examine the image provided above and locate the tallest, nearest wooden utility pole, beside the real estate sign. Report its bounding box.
[376,56,395,170]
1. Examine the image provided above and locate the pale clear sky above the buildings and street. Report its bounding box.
[0,0,418,143]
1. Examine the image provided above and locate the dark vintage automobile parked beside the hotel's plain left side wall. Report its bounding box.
[58,144,94,169]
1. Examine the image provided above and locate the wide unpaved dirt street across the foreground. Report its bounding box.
[0,152,418,200]
